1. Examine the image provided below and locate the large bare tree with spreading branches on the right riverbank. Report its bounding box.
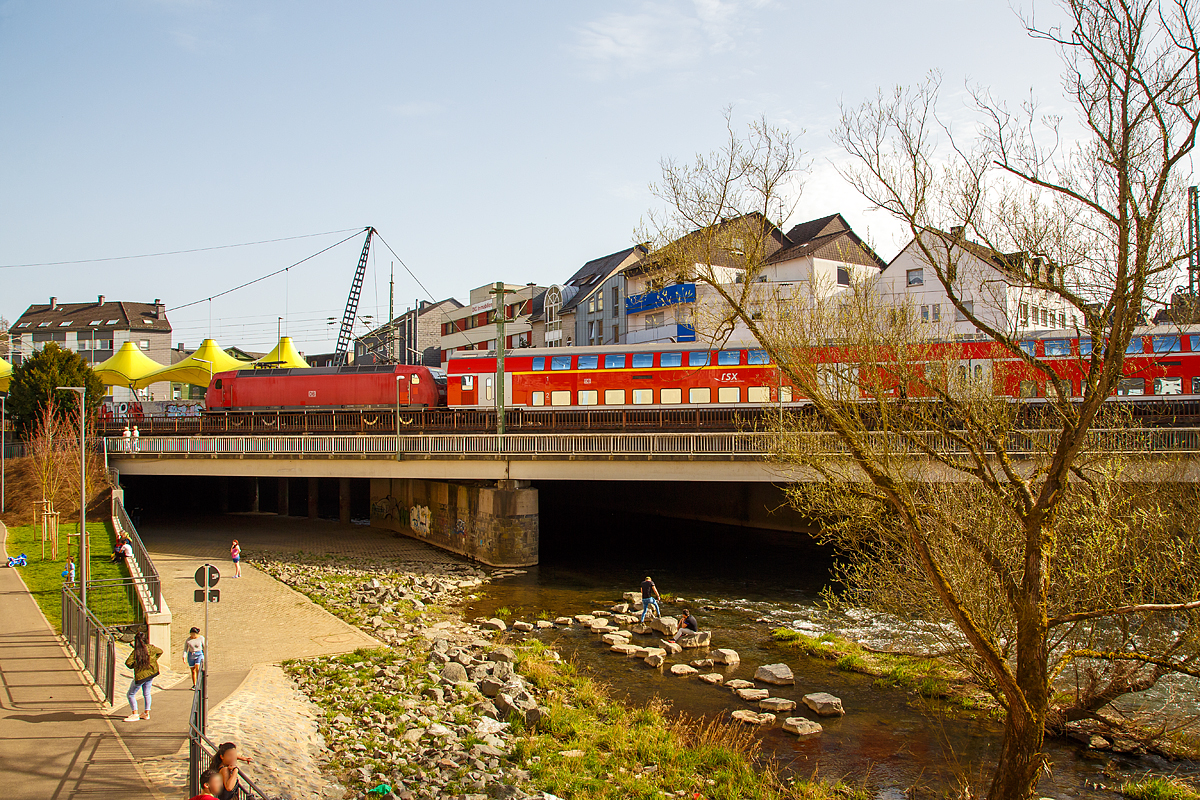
[640,0,1200,800]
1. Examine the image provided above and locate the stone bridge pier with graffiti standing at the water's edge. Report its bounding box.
[371,477,539,566]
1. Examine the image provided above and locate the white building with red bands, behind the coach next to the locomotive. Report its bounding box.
[438,283,546,363]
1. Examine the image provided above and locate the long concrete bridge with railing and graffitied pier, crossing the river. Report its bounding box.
[103,428,1200,566]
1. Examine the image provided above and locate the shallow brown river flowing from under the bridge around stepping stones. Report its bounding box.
[466,515,1200,798]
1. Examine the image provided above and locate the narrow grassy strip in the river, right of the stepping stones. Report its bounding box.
[770,627,990,710]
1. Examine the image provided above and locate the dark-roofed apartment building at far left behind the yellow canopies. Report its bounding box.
[10,295,172,402]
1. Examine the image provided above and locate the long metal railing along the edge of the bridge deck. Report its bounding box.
[104,428,1200,459]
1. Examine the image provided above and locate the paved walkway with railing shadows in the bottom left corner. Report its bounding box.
[0,525,160,800]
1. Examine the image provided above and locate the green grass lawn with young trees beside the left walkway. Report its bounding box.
[0,522,137,631]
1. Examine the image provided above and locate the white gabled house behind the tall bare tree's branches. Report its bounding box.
[880,228,1080,336]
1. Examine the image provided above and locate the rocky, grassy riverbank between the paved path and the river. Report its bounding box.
[255,554,865,800]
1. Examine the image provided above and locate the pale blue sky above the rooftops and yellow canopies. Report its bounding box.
[0,0,1062,353]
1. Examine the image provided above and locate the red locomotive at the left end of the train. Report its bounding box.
[205,365,445,411]
